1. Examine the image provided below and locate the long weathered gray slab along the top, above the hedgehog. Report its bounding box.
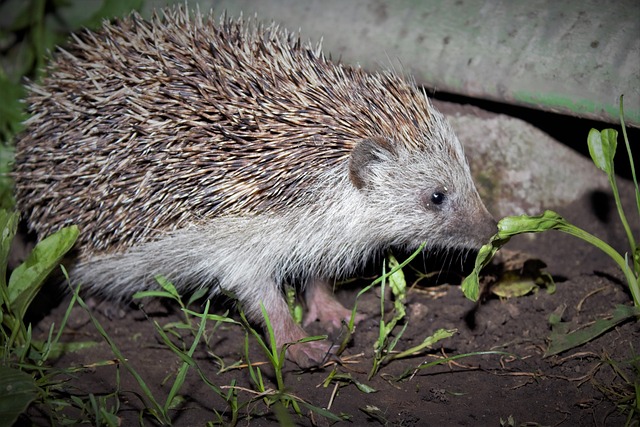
[146,0,640,126]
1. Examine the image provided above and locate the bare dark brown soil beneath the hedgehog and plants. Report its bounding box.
[17,112,640,426]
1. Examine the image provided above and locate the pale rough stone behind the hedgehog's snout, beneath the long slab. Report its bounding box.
[440,104,608,217]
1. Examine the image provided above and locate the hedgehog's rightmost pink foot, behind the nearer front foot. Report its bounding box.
[304,279,364,332]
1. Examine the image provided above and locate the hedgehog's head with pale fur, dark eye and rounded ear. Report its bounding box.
[349,127,496,248]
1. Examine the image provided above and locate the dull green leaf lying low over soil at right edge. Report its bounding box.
[544,305,640,357]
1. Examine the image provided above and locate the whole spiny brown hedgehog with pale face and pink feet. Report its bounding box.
[14,7,496,367]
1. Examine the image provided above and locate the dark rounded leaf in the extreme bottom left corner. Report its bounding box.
[0,366,38,427]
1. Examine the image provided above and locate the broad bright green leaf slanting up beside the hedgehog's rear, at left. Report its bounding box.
[9,225,79,319]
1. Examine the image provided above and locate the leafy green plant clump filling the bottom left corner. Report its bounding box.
[0,210,113,425]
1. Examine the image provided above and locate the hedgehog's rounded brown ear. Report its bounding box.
[349,136,396,189]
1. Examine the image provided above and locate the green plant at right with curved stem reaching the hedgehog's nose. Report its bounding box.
[462,97,640,356]
